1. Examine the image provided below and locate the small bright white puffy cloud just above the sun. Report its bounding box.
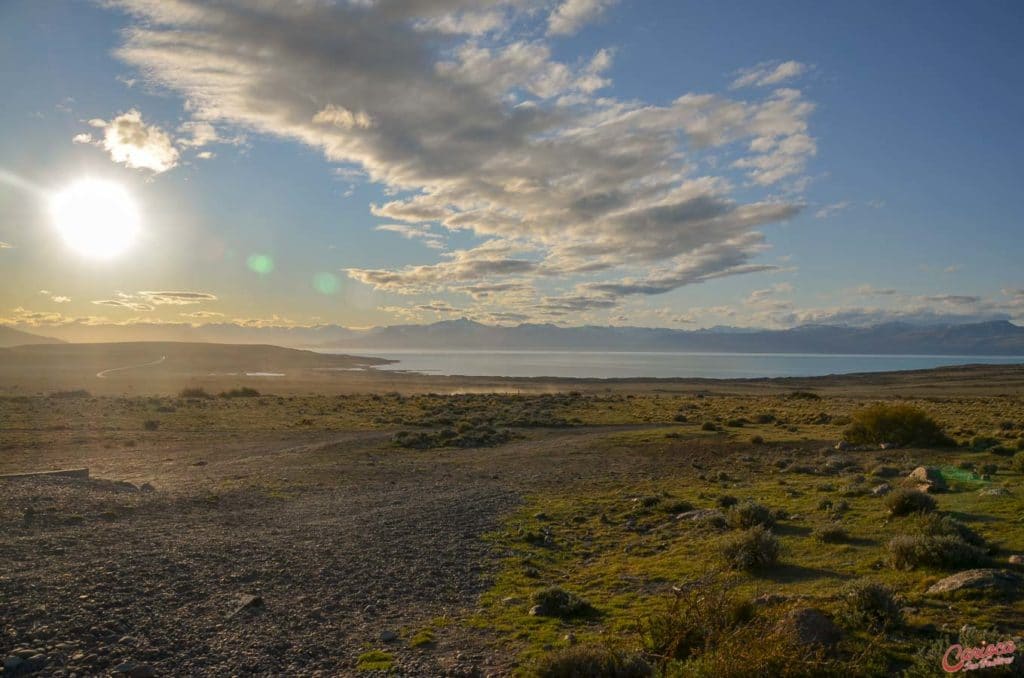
[84,109,179,174]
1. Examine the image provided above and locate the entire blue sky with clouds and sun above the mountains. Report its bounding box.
[0,0,1024,334]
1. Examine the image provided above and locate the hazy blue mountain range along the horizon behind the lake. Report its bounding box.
[0,319,1024,355]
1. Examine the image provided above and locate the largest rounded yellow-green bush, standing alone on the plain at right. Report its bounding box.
[843,402,955,448]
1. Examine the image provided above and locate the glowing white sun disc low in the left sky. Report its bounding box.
[50,179,139,259]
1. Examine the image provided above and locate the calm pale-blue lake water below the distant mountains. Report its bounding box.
[323,349,1024,379]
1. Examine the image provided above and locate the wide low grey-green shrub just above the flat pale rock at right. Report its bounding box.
[887,514,988,569]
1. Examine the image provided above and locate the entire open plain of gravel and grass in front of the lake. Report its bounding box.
[0,348,1024,676]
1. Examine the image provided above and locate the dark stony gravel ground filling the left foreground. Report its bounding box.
[0,429,715,676]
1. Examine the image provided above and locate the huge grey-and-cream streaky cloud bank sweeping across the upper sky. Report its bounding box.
[103,0,816,323]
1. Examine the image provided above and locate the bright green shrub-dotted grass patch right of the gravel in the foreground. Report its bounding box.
[473,397,1024,675]
